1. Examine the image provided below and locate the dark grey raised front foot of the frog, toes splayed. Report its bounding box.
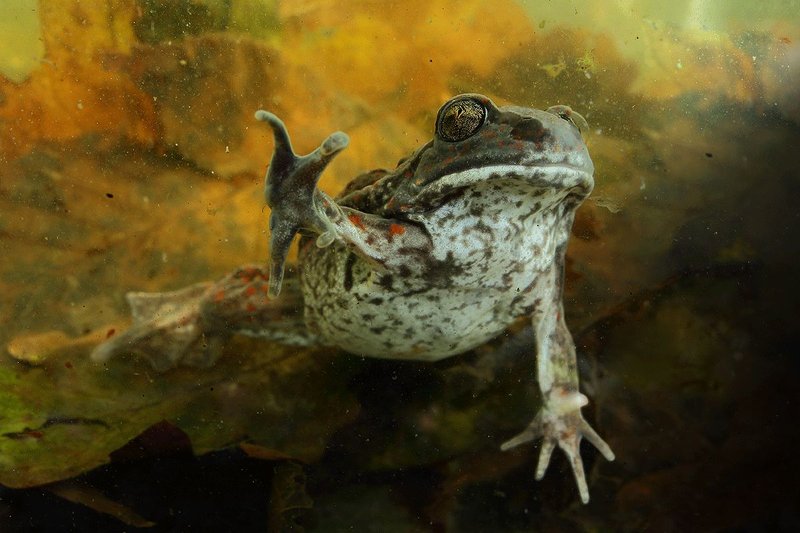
[256,110,350,298]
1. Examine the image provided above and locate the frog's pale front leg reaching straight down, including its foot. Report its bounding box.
[501,268,614,503]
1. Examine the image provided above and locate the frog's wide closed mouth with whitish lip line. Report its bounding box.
[401,163,594,212]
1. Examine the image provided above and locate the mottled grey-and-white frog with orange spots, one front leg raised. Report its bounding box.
[92,93,615,503]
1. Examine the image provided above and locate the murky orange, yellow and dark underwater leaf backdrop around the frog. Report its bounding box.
[0,0,800,532]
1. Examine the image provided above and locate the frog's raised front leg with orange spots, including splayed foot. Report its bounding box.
[256,110,432,297]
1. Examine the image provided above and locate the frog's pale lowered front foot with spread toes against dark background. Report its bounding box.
[500,390,614,503]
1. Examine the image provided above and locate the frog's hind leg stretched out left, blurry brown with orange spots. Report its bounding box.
[92,266,316,371]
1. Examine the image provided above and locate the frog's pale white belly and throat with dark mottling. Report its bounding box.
[303,180,572,361]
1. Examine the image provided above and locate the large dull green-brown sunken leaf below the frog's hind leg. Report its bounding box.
[0,332,358,487]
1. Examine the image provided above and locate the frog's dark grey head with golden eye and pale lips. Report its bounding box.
[385,94,594,213]
